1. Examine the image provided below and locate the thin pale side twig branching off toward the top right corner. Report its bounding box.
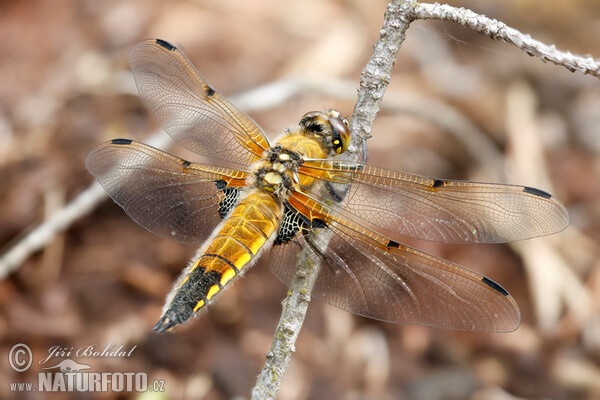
[413,3,600,78]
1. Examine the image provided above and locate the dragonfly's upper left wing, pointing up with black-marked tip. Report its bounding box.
[129,39,269,166]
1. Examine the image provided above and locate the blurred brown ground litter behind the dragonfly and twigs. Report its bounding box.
[0,0,600,400]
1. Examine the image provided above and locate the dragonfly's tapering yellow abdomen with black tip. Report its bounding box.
[154,191,283,332]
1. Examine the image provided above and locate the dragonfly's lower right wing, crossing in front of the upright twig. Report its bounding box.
[270,197,521,332]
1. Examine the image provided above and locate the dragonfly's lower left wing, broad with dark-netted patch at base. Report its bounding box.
[86,139,246,244]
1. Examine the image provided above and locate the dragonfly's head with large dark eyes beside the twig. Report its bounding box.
[300,110,350,154]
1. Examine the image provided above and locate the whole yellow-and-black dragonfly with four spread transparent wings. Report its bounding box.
[86,39,568,332]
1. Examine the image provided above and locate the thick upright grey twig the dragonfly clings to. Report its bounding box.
[252,1,410,399]
